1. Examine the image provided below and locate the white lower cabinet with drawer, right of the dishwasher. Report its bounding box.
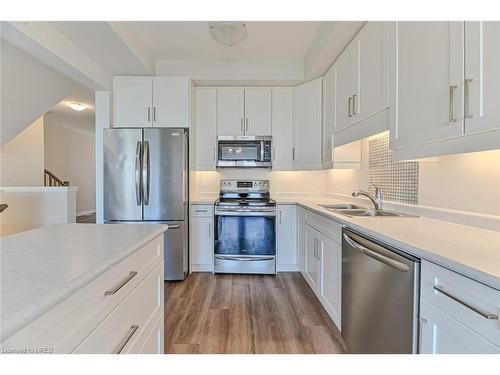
[420,260,500,354]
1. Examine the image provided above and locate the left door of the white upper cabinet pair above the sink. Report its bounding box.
[334,50,352,133]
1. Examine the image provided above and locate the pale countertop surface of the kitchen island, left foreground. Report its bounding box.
[0,224,168,340]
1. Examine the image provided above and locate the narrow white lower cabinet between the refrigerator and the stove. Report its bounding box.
[189,204,214,272]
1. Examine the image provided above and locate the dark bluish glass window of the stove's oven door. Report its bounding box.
[214,215,276,255]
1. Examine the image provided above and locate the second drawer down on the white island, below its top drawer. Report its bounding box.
[74,263,163,353]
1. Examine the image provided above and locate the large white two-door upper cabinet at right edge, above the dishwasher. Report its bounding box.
[391,22,500,159]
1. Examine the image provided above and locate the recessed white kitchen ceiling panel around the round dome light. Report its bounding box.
[124,21,323,61]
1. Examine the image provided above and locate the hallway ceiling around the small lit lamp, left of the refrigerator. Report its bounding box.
[45,86,95,133]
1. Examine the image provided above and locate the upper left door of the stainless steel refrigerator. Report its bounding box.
[104,129,142,221]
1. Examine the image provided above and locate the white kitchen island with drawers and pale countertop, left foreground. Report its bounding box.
[0,224,168,353]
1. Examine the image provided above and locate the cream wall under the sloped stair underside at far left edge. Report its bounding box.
[0,117,44,186]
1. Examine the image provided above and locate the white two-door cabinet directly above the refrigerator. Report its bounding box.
[112,77,191,128]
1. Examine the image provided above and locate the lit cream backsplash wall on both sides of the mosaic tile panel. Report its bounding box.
[327,139,500,215]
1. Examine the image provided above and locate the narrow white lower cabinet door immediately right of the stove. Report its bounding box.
[276,205,297,271]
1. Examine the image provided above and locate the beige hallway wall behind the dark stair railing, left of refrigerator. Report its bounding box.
[45,121,96,213]
